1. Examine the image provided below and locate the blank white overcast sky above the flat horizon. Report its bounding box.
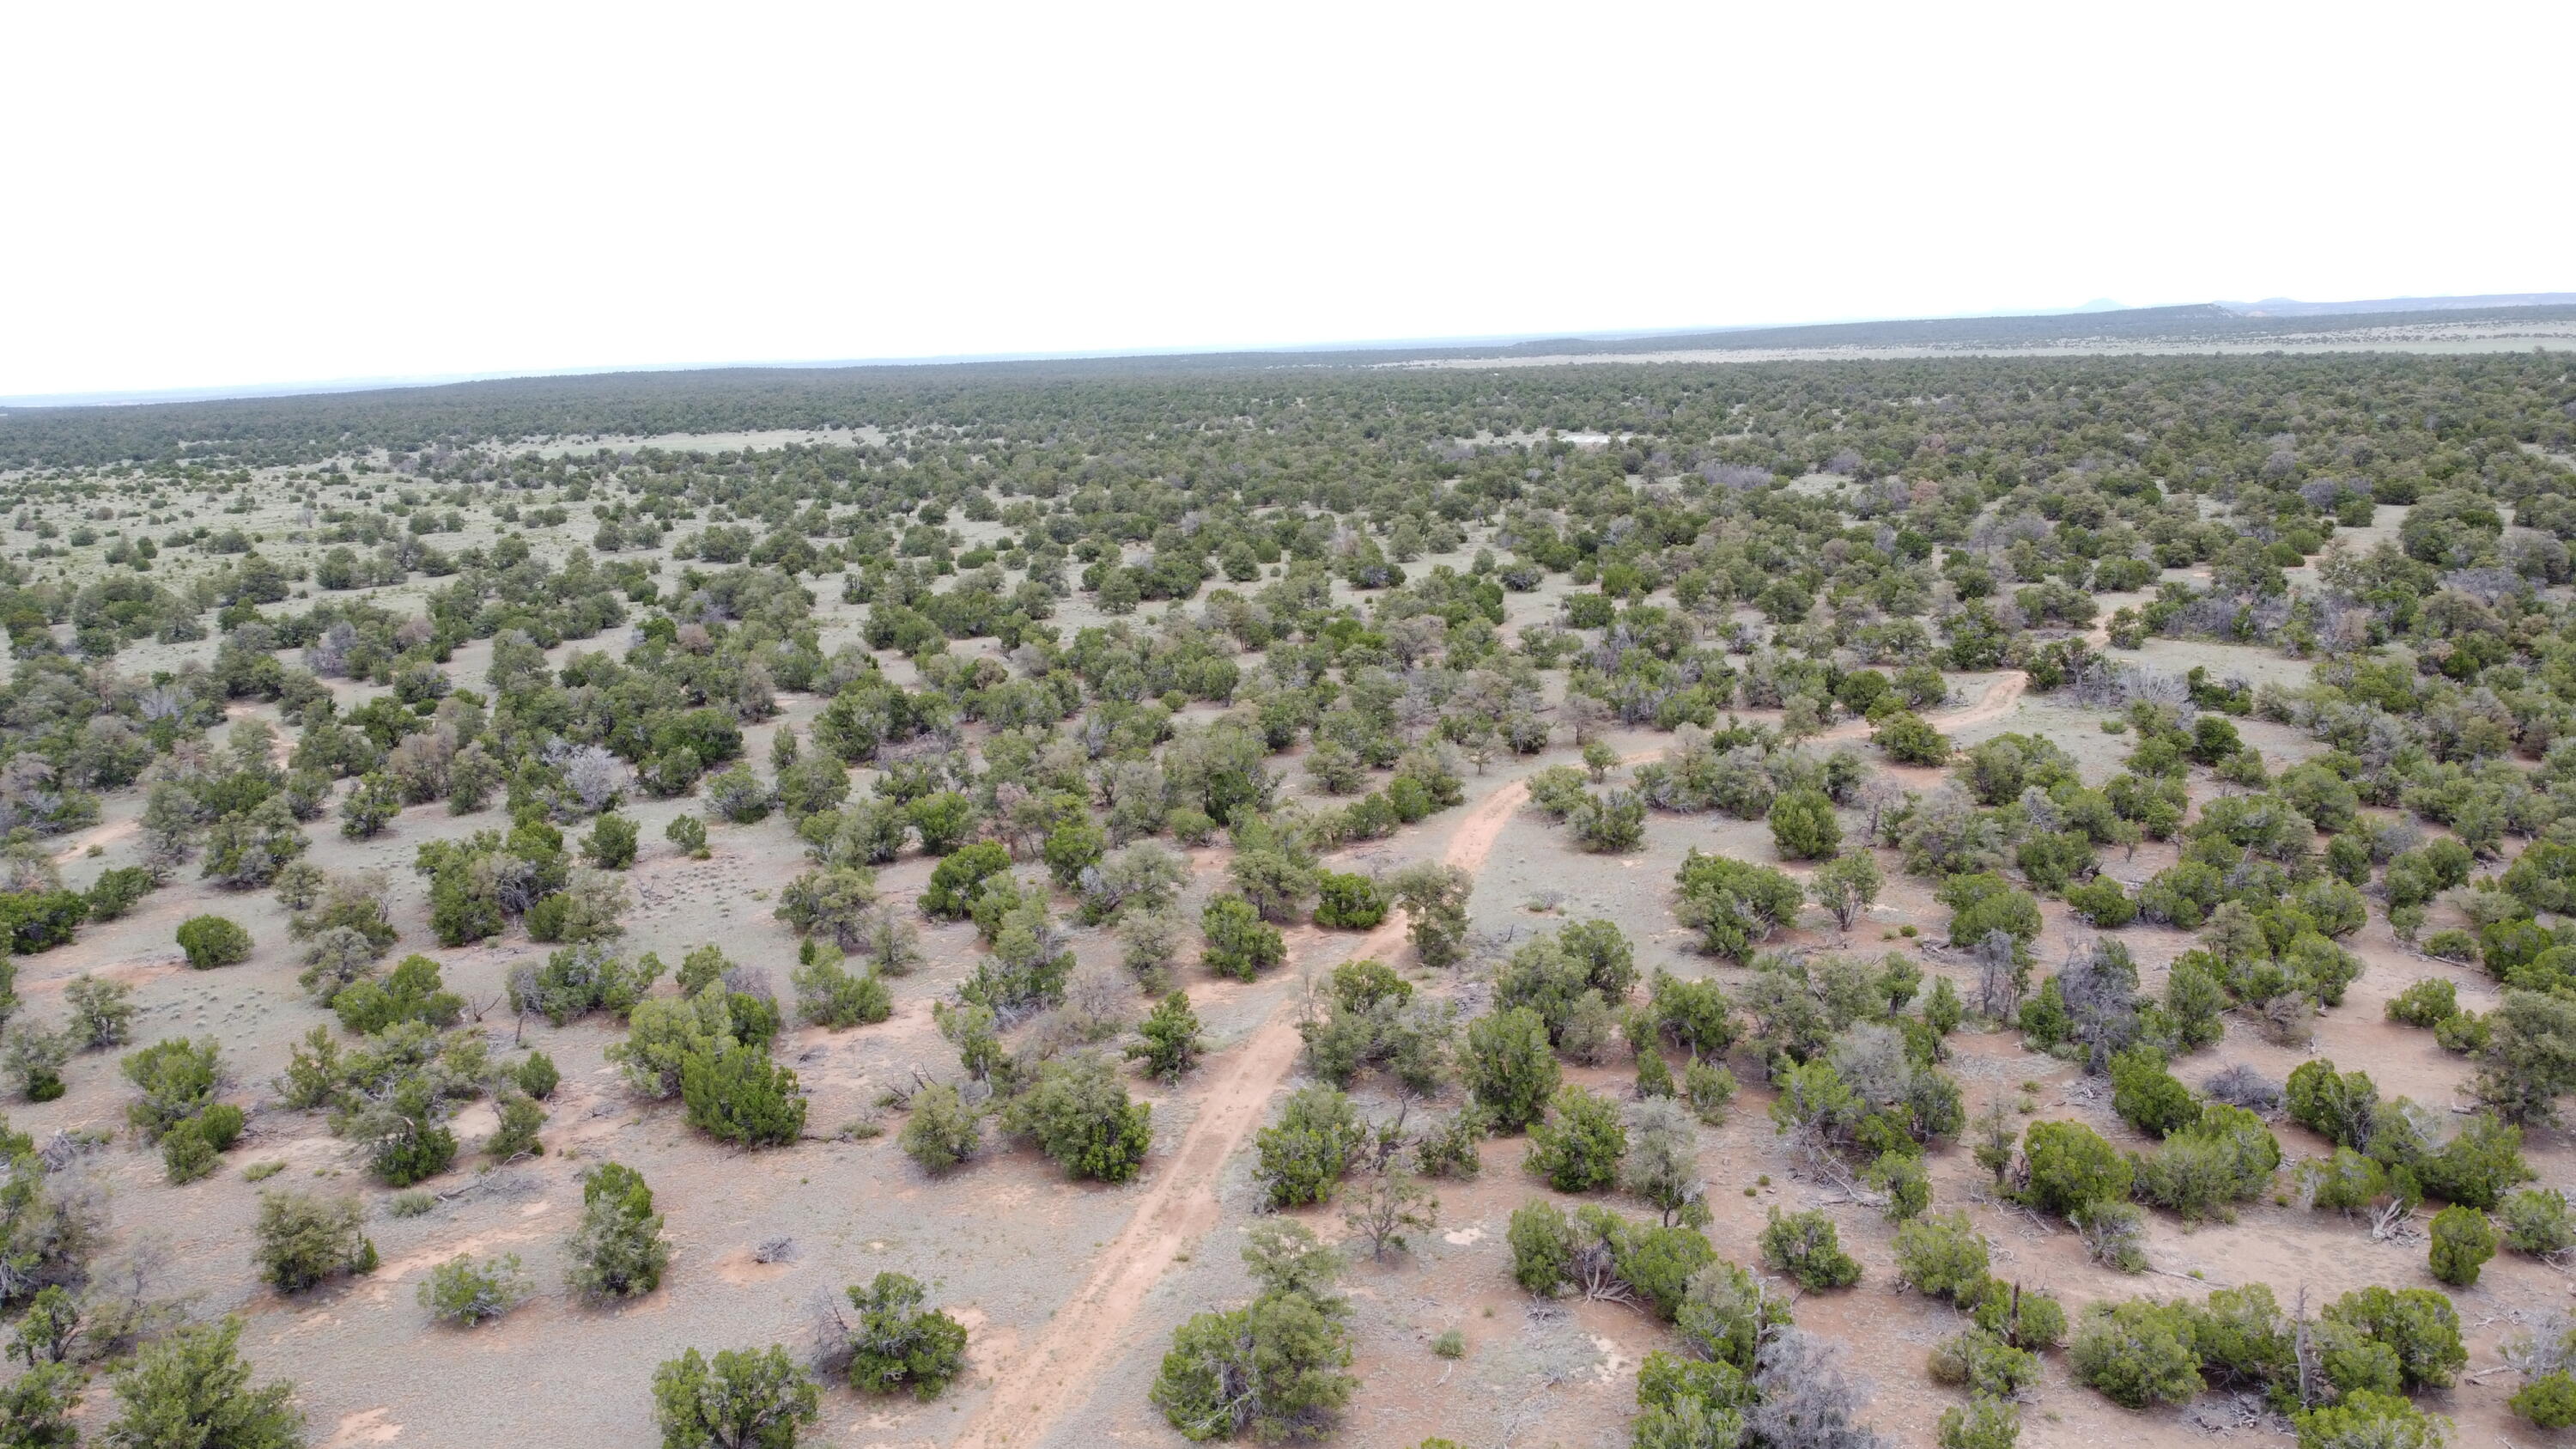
[0,0,2576,397]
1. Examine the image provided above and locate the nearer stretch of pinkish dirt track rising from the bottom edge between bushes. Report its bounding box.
[956,782,1530,1449]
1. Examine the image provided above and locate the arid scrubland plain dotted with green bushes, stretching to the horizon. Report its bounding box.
[0,343,2576,1449]
